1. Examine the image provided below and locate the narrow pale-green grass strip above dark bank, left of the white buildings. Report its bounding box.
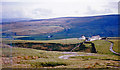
[3,38,83,44]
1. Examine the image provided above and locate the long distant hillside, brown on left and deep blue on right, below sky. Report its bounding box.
[2,15,120,40]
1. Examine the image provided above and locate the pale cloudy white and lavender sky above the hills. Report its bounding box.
[0,0,119,19]
